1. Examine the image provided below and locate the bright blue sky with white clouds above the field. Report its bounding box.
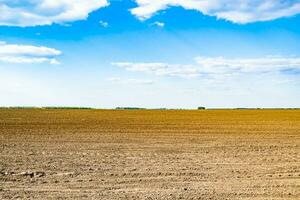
[0,0,300,109]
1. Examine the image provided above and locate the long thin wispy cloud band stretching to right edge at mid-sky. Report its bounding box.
[112,57,300,78]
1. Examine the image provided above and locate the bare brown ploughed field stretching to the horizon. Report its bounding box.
[0,109,300,200]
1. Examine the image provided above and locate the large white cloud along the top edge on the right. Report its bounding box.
[131,0,300,24]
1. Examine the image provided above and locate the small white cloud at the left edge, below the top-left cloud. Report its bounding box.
[0,41,61,64]
